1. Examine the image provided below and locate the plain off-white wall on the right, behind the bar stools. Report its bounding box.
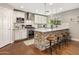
[52,9,79,41]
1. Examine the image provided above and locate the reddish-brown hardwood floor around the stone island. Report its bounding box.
[0,41,79,55]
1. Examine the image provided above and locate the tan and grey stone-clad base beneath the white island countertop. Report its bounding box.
[34,29,69,51]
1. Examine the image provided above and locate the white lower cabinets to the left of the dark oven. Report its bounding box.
[15,29,27,40]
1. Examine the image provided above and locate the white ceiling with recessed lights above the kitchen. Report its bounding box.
[8,3,79,15]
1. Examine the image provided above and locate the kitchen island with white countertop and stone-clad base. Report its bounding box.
[34,26,69,51]
